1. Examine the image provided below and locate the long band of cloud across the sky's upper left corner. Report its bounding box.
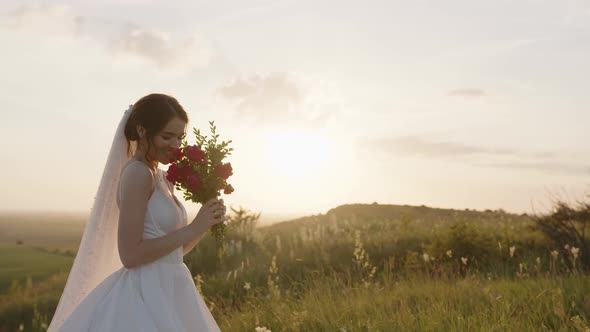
[0,4,214,71]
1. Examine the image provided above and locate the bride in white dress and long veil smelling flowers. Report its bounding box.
[48,94,226,332]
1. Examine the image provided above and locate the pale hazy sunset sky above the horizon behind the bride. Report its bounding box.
[0,0,590,222]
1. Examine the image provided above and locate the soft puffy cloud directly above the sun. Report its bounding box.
[216,72,340,127]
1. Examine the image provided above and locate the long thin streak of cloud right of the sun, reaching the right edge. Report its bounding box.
[357,136,590,175]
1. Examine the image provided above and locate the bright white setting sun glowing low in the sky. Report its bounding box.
[264,129,334,177]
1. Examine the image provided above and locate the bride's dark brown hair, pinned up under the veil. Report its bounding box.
[125,93,188,162]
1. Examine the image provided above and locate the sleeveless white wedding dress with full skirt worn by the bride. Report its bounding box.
[59,160,220,332]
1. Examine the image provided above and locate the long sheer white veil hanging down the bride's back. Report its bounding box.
[48,105,137,332]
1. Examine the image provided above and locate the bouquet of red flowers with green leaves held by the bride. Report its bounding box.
[166,121,234,245]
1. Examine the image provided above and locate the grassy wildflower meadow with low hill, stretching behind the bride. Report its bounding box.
[0,204,590,331]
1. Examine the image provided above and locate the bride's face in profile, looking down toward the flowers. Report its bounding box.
[142,117,186,164]
